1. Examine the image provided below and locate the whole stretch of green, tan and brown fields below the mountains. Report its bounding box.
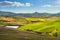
[0,17,60,40]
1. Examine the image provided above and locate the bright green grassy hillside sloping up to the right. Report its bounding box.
[19,18,60,36]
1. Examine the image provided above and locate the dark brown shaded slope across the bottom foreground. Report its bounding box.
[0,27,59,40]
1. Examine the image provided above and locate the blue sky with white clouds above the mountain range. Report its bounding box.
[0,0,60,13]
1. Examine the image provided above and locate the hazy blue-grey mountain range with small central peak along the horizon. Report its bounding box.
[0,11,60,17]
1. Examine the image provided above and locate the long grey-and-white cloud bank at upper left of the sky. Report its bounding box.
[0,1,31,7]
